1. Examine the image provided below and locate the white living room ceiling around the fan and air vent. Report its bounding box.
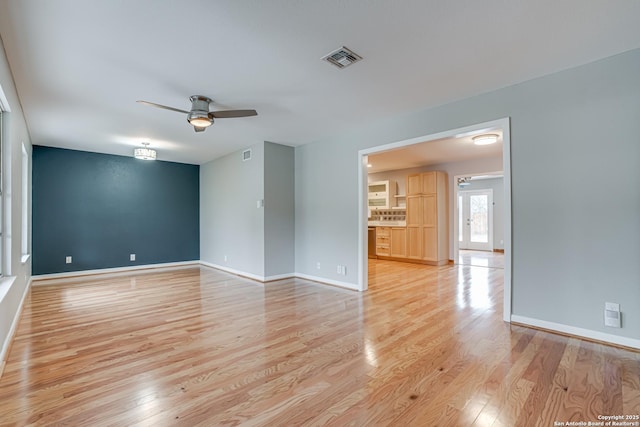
[0,0,640,164]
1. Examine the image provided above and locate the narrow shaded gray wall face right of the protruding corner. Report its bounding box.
[264,142,295,277]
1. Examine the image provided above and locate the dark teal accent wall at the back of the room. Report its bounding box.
[33,146,200,274]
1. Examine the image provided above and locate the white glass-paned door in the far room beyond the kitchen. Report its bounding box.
[458,189,493,251]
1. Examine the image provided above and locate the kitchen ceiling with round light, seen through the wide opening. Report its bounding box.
[367,129,502,173]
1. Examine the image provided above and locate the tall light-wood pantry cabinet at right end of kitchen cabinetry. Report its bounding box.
[406,171,449,265]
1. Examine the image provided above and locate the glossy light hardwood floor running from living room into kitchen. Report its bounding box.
[0,260,640,426]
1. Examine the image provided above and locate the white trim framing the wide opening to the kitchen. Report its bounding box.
[357,117,513,322]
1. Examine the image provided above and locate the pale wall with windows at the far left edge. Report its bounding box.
[0,38,31,366]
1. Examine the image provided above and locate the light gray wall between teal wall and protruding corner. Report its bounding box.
[200,142,265,277]
